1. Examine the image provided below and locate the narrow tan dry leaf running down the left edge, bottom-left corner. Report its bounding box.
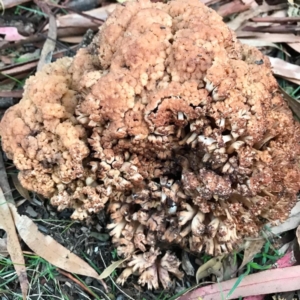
[0,188,28,300]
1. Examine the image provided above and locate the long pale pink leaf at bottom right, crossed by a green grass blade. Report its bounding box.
[179,266,300,300]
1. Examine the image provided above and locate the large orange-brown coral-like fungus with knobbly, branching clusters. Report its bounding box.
[0,0,300,288]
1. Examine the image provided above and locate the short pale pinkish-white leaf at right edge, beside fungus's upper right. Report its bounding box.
[269,57,300,80]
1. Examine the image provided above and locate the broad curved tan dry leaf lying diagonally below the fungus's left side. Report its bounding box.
[9,204,99,279]
